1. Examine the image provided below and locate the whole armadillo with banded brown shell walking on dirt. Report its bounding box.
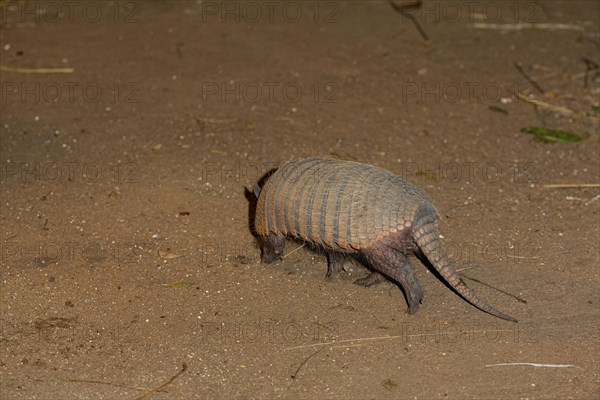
[254,157,517,322]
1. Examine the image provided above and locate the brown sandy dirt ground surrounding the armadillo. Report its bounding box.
[0,1,600,400]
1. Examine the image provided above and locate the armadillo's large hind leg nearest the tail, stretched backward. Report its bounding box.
[361,245,423,314]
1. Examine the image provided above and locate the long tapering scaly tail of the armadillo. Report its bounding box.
[413,206,517,322]
